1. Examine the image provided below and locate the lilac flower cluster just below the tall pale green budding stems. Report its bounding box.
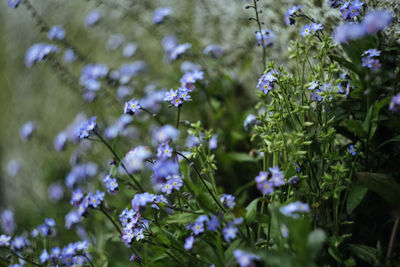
[255,166,285,195]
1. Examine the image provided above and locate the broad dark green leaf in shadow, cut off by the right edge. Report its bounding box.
[356,172,400,206]
